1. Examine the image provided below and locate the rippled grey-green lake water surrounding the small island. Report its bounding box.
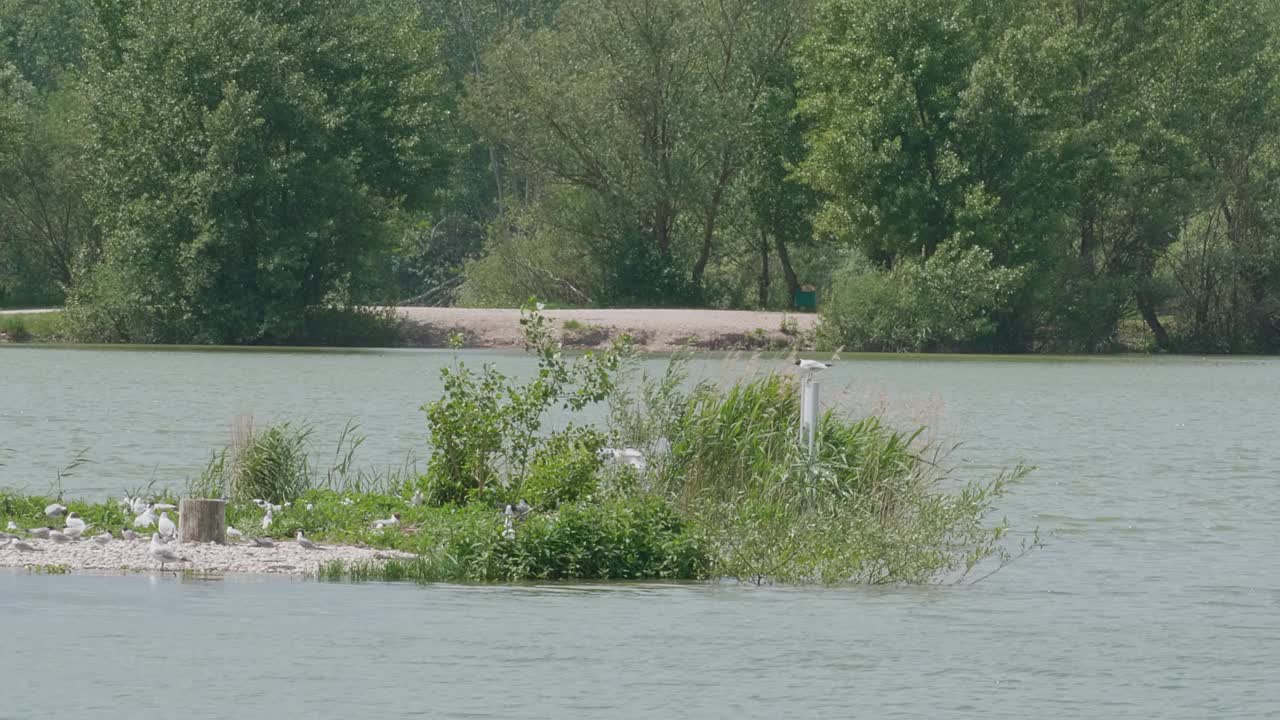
[0,347,1280,719]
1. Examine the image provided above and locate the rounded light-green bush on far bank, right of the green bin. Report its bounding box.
[818,243,1021,352]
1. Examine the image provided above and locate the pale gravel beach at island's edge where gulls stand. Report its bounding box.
[0,539,413,575]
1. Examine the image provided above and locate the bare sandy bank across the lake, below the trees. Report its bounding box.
[397,307,818,352]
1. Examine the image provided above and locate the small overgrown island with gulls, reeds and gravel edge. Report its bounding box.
[0,306,1025,583]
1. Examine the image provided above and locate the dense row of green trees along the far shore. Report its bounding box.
[0,0,1280,352]
